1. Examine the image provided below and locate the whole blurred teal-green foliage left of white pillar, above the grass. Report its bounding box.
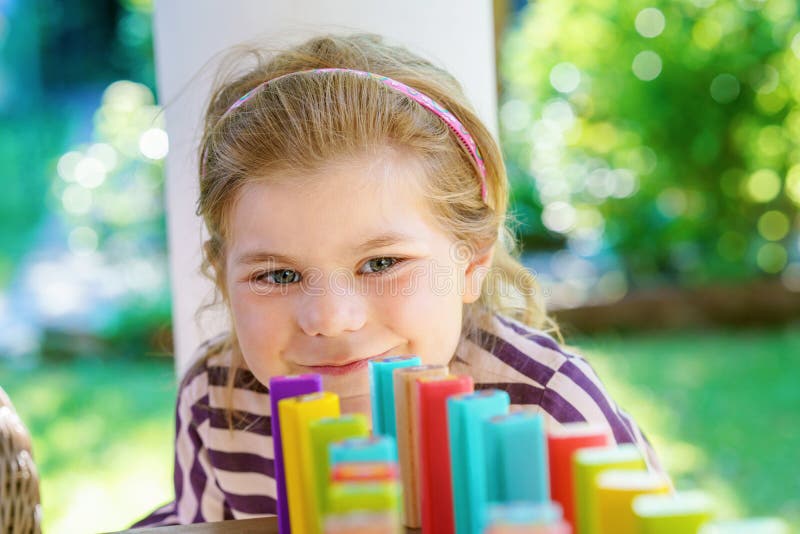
[0,0,171,358]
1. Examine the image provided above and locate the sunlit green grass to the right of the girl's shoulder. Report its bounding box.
[572,328,800,528]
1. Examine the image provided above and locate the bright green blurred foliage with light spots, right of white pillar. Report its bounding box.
[501,0,800,287]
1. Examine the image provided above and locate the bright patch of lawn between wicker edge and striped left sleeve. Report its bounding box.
[0,358,176,533]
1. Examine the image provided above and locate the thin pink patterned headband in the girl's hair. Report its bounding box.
[212,68,487,202]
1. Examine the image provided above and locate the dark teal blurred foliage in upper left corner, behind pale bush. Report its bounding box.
[0,0,155,272]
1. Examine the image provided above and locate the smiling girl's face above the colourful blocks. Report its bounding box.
[226,150,491,416]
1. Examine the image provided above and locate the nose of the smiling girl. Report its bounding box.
[297,281,366,337]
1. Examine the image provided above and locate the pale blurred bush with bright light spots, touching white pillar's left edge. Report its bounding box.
[51,77,171,350]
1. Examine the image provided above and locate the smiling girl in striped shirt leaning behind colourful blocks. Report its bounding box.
[134,35,661,527]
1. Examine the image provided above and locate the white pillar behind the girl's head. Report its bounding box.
[154,0,497,376]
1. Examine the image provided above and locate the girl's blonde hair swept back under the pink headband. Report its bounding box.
[191,34,561,426]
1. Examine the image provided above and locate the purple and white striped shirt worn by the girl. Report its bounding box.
[133,314,664,527]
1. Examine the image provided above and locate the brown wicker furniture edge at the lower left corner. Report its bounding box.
[0,388,41,534]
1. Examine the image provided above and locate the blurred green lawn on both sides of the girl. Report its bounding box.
[0,329,800,534]
